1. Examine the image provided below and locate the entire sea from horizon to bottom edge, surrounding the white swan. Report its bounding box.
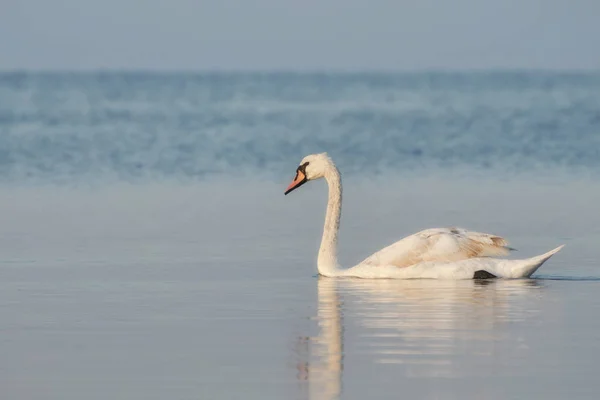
[0,71,600,400]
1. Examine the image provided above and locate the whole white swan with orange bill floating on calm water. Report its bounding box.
[285,153,564,280]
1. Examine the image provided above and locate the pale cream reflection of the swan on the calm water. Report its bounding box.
[297,277,543,399]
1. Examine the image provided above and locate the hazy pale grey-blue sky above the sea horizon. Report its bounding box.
[0,0,600,71]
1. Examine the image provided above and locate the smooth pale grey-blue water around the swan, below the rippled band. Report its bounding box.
[0,179,600,399]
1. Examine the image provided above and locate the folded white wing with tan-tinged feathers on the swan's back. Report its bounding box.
[361,228,512,267]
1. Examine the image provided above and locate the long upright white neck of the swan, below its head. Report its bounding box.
[317,164,342,276]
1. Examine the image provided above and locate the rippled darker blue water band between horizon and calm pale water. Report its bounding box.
[0,72,600,183]
